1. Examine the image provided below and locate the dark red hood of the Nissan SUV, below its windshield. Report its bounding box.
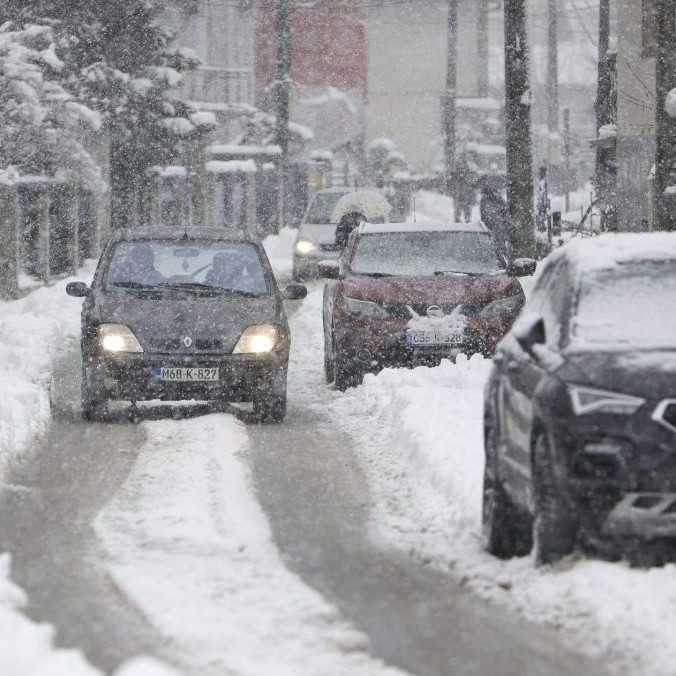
[343,274,523,306]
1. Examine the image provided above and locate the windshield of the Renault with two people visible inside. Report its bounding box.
[105,240,269,295]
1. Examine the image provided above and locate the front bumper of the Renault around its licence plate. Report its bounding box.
[87,353,288,402]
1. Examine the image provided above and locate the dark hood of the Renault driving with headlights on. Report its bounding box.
[91,293,281,352]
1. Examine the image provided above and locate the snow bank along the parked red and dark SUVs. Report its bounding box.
[290,289,676,676]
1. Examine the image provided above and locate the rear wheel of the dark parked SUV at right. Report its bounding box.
[481,426,531,559]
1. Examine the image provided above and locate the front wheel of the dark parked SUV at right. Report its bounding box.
[533,434,577,566]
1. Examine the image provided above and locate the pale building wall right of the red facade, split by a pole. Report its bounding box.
[366,0,480,170]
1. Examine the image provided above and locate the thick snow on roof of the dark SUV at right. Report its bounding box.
[550,232,676,271]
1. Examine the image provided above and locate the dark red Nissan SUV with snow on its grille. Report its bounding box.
[320,223,536,389]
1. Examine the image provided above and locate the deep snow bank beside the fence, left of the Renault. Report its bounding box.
[0,262,94,481]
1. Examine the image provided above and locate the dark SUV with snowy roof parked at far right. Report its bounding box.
[483,233,676,563]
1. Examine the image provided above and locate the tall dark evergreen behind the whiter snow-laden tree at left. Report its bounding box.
[0,0,197,226]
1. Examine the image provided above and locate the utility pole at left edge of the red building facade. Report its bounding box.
[275,0,291,231]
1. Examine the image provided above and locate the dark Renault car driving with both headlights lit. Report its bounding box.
[66,228,307,421]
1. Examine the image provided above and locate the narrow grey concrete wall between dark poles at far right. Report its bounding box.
[615,0,655,230]
